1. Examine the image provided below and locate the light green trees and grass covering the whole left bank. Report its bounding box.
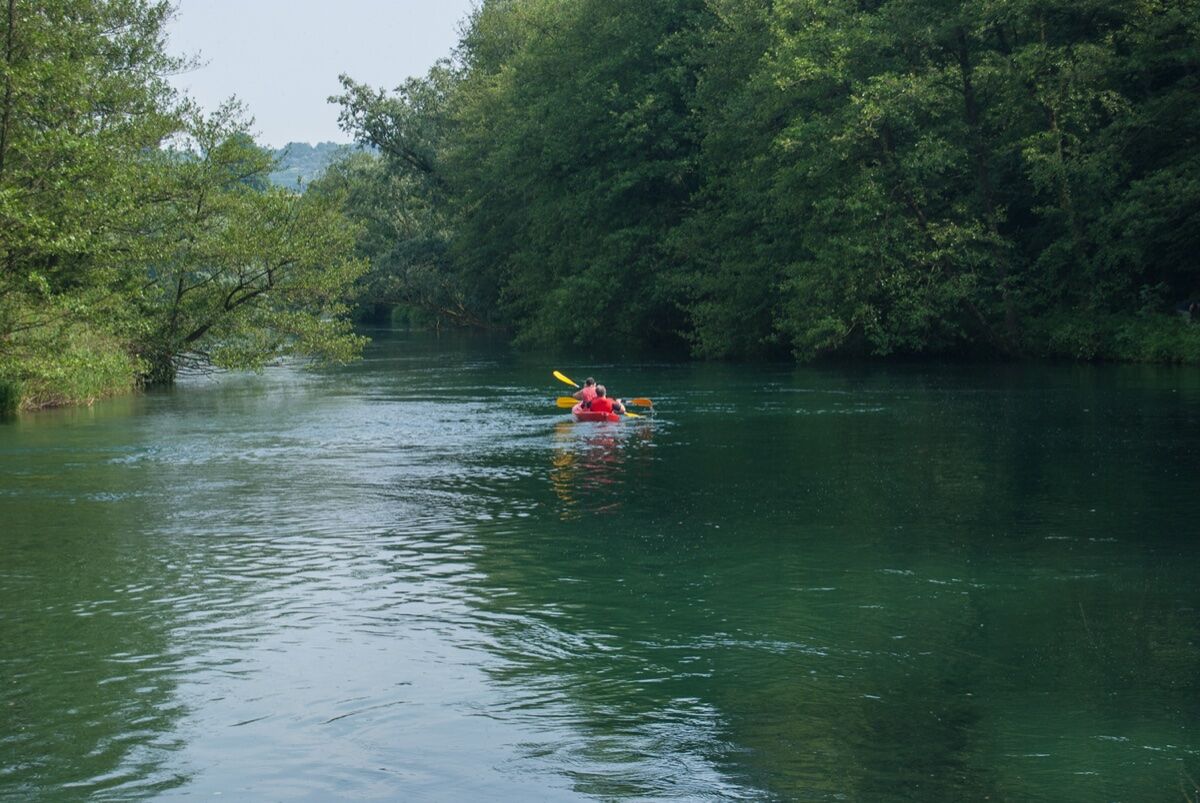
[0,0,364,408]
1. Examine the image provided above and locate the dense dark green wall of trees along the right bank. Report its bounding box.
[330,0,1200,360]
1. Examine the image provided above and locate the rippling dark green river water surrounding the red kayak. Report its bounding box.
[0,334,1200,801]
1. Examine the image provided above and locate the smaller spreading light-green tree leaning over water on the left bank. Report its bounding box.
[134,104,366,382]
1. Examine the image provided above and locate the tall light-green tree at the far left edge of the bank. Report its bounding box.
[0,0,184,405]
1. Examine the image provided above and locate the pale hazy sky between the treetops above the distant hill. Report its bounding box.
[167,0,473,148]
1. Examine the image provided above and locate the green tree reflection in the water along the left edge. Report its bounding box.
[0,444,191,799]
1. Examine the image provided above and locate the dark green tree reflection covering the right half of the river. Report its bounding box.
[463,372,1200,799]
